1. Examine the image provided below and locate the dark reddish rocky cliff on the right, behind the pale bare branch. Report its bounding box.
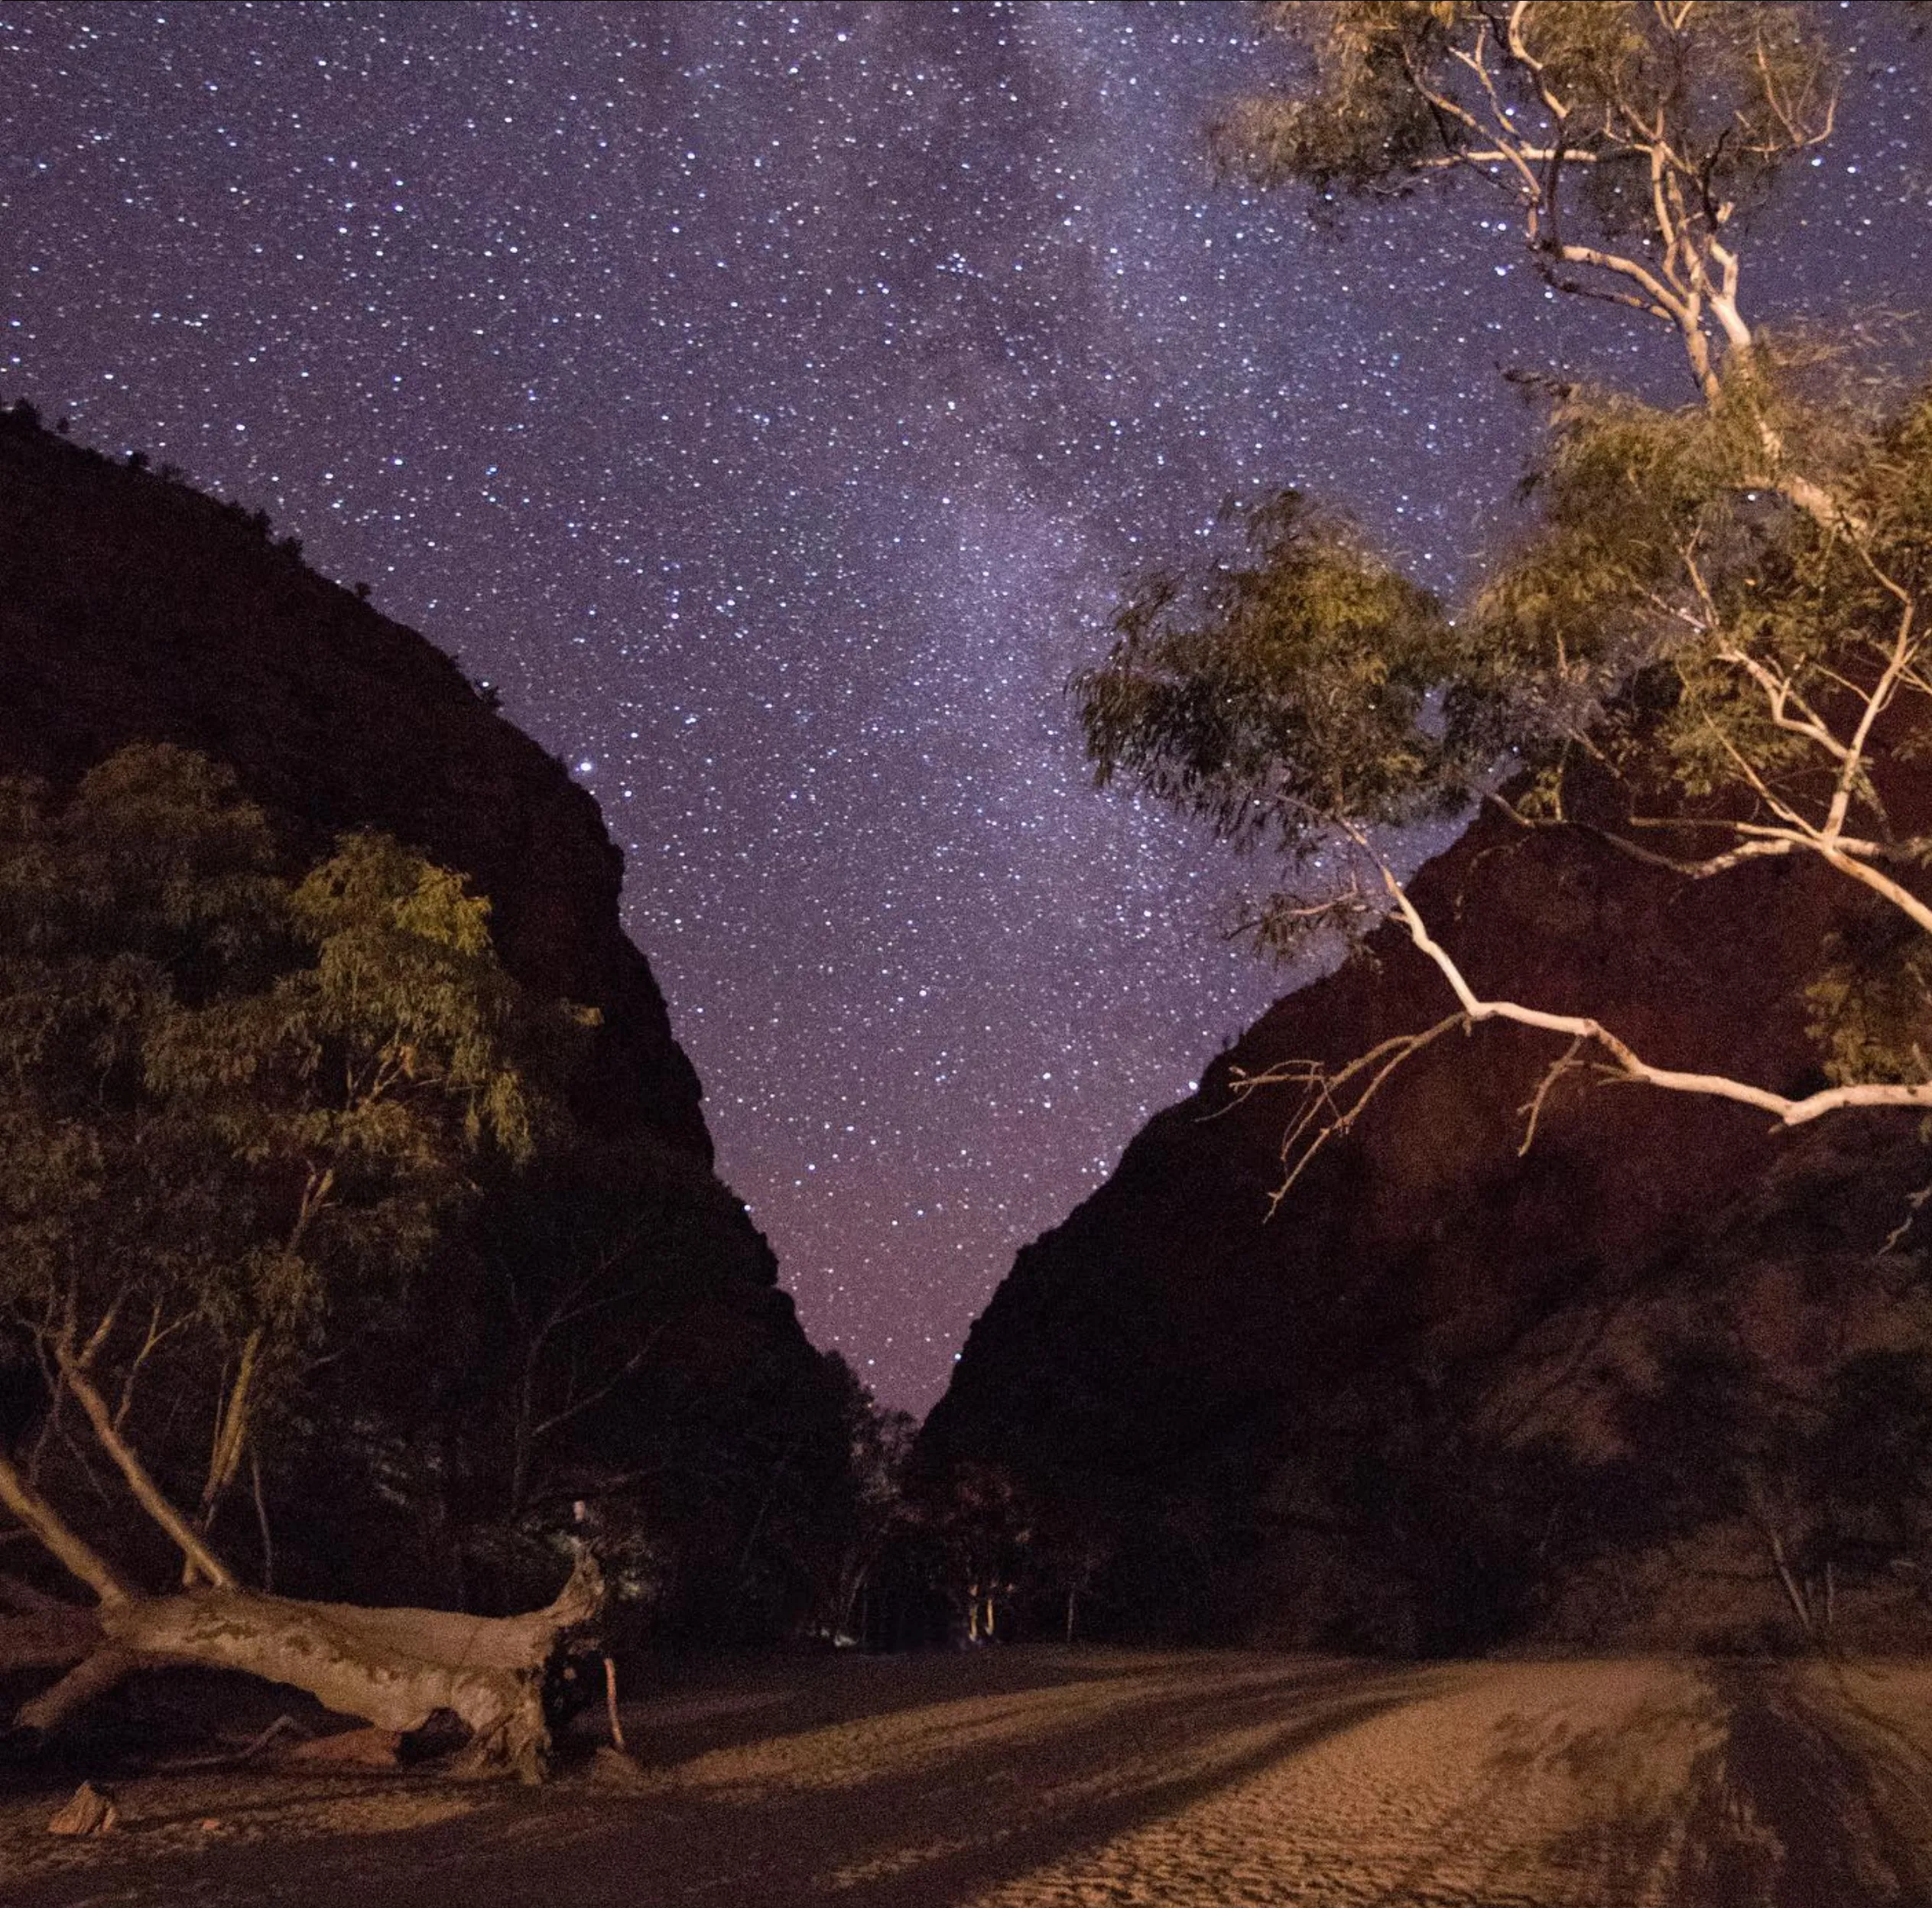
[921,792,1932,1649]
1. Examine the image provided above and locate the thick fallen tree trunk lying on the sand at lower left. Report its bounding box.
[14,1552,605,1783]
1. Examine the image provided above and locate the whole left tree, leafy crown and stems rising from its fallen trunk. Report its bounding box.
[0,746,601,1773]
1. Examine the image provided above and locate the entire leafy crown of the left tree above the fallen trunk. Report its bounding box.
[0,746,560,1507]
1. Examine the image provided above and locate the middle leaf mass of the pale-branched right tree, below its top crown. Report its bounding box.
[1074,363,1932,1000]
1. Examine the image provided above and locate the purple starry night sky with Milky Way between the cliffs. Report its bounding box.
[0,0,1932,1409]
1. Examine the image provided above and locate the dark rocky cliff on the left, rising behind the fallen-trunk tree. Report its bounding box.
[0,408,846,1636]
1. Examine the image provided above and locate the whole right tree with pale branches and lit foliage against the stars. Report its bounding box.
[1076,0,1932,1197]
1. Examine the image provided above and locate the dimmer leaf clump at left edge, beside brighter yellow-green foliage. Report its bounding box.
[0,750,278,1332]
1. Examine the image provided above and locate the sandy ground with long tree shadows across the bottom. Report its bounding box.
[0,1651,1932,1908]
